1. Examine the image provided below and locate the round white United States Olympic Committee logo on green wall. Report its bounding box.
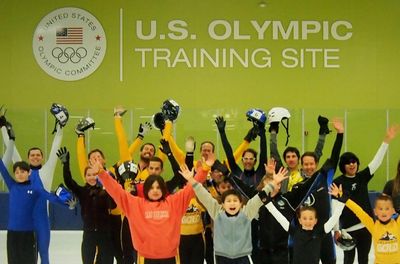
[33,7,107,81]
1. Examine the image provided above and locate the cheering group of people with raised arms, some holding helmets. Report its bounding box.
[0,99,400,264]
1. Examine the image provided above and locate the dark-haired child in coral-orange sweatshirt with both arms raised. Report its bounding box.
[92,155,215,264]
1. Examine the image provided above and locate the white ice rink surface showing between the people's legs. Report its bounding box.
[0,230,374,264]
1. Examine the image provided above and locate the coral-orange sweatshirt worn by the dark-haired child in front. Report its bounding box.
[99,169,208,259]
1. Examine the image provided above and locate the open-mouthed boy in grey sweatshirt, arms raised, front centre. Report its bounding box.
[185,168,287,264]
